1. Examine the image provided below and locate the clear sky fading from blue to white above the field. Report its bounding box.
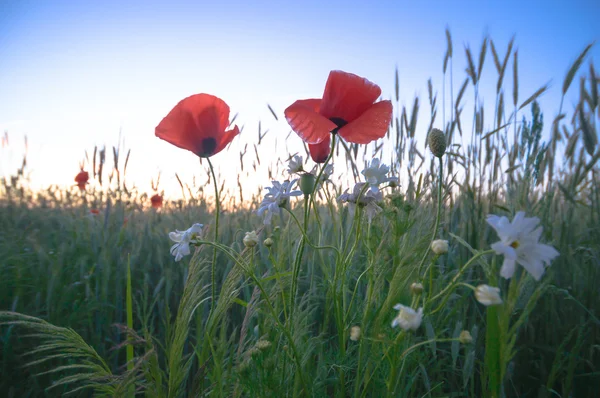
[0,0,600,201]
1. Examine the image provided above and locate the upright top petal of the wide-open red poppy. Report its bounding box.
[320,70,381,123]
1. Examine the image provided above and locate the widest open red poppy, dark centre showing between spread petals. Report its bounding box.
[285,70,393,144]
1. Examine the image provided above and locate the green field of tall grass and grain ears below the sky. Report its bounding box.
[0,34,600,397]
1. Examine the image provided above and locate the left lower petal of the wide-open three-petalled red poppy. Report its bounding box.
[284,99,337,144]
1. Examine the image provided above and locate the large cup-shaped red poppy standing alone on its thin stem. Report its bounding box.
[155,94,240,158]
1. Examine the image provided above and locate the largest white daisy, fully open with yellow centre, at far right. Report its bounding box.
[487,211,559,281]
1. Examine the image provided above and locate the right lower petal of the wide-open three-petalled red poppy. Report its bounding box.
[338,100,393,144]
